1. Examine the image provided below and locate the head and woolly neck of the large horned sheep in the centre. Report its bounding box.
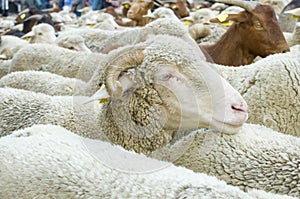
[92,35,247,152]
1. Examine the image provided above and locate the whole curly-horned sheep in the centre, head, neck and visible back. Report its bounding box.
[0,35,247,154]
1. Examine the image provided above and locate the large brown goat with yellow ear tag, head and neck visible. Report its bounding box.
[200,0,289,66]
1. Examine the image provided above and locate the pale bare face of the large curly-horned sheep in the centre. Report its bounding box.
[154,63,248,133]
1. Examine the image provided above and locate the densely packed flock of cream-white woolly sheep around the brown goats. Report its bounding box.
[0,0,300,199]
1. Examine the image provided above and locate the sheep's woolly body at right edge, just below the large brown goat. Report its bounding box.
[210,52,300,136]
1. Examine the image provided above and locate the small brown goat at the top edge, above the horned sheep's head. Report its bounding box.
[127,0,154,26]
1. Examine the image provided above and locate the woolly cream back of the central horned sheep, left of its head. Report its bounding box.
[0,88,106,140]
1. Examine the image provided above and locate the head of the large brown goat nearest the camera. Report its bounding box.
[211,0,289,57]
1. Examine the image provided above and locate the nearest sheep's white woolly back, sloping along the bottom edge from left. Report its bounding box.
[0,125,292,199]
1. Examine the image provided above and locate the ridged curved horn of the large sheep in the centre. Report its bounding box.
[105,48,144,98]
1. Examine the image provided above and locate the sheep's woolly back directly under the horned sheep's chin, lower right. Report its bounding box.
[151,124,300,198]
